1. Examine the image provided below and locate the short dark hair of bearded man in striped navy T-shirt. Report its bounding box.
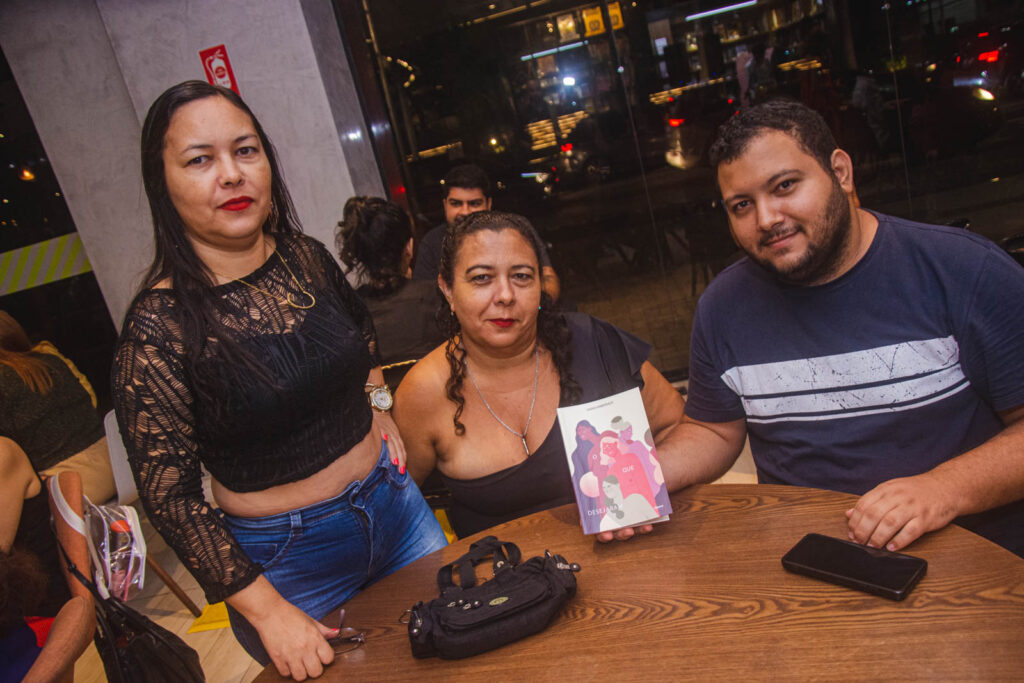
[708,99,839,173]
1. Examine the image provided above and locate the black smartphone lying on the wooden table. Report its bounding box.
[782,533,928,600]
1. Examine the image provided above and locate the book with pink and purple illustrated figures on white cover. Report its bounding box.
[558,388,672,533]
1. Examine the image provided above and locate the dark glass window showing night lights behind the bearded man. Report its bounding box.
[356,0,1024,371]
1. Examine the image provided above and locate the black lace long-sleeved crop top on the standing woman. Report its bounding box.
[113,234,380,603]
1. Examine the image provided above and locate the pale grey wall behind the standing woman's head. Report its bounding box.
[0,0,383,326]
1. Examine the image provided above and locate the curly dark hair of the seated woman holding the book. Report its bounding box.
[437,211,581,436]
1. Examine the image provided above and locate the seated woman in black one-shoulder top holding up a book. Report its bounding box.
[395,211,683,540]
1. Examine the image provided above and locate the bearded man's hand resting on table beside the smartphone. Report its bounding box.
[846,472,957,550]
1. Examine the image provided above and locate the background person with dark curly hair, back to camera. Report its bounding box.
[336,197,444,366]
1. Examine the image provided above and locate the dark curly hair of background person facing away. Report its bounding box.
[335,197,413,297]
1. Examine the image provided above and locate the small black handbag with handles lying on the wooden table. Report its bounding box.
[409,536,580,659]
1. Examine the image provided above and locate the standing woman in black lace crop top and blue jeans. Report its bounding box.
[113,81,444,680]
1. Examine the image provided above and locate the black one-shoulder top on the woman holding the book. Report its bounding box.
[440,313,650,538]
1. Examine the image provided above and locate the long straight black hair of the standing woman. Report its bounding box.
[141,81,302,393]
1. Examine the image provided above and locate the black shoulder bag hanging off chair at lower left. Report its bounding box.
[57,544,206,683]
